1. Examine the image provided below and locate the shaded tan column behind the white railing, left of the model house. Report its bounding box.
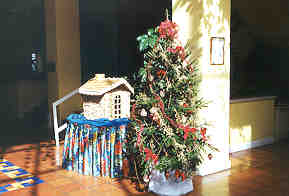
[45,0,81,120]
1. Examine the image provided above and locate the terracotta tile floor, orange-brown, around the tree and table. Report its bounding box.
[0,136,289,196]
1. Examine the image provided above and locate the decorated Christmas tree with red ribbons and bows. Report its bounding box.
[127,14,216,187]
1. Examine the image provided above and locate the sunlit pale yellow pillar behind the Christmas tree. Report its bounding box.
[172,0,231,175]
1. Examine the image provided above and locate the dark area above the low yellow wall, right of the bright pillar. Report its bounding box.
[231,0,289,103]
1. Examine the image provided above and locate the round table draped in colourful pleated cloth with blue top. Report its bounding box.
[62,114,129,178]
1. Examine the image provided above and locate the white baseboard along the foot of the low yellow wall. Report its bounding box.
[230,137,274,153]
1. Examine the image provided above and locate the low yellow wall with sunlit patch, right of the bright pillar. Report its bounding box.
[230,98,274,149]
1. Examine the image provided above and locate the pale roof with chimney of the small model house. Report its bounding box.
[79,74,134,96]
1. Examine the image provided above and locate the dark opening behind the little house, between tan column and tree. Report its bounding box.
[79,0,171,82]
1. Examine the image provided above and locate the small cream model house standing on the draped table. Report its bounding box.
[79,74,134,120]
